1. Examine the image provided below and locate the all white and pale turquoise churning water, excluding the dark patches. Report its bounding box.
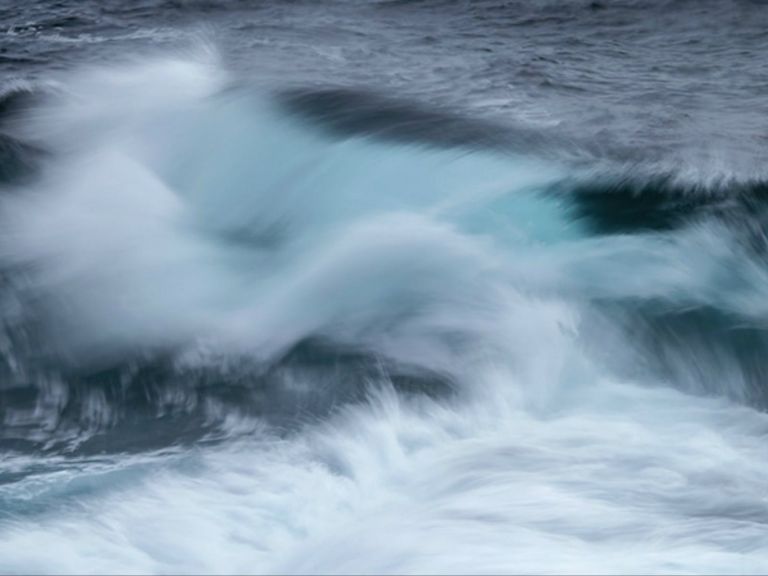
[0,61,768,573]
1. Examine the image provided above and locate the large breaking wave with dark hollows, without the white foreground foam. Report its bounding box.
[0,55,768,449]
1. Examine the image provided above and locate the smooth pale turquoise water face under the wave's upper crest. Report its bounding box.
[148,94,583,248]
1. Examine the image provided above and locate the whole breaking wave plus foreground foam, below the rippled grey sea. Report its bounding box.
[0,53,768,573]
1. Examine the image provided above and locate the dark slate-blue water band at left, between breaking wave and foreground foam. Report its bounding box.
[0,339,453,455]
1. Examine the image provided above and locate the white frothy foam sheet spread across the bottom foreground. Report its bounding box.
[0,370,768,574]
